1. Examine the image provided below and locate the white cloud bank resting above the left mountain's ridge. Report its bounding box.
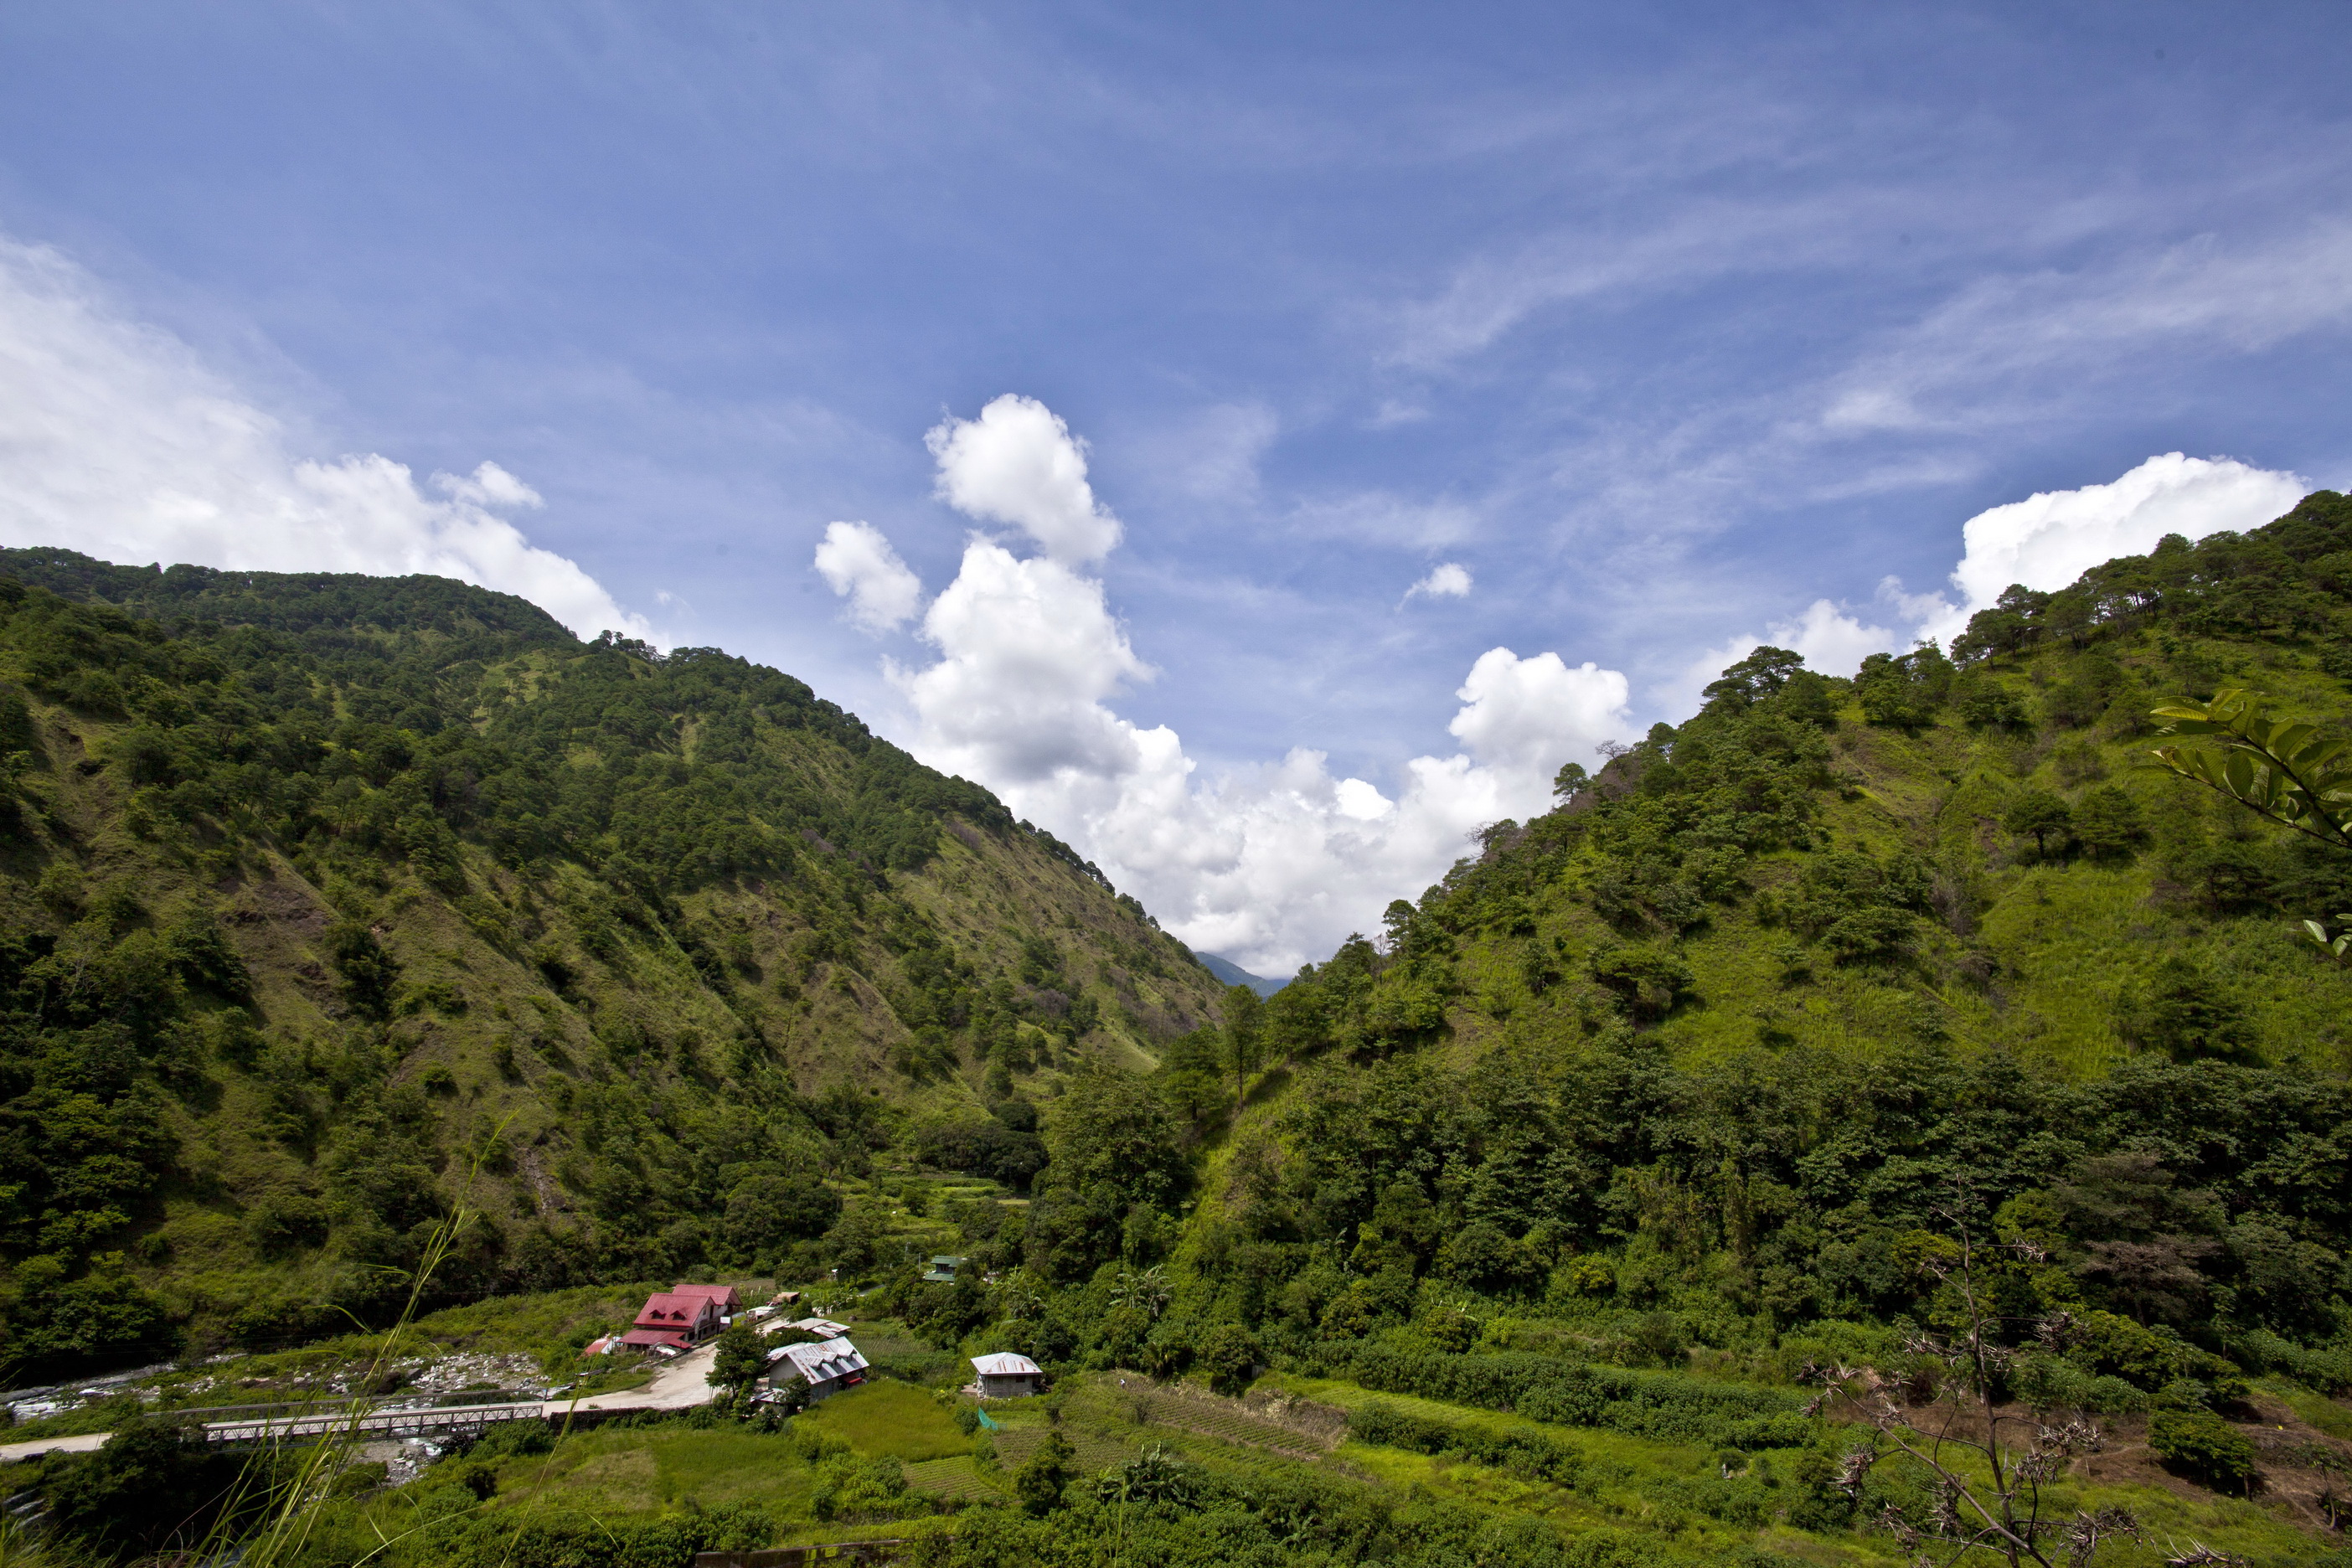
[0,240,656,639]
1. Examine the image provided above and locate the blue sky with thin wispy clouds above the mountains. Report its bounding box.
[0,0,2352,964]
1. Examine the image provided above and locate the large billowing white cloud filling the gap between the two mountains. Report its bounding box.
[846,397,1630,973]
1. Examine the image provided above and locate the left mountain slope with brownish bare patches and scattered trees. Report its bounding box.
[0,550,1220,1375]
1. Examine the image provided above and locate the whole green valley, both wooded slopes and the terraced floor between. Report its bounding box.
[0,492,2352,1568]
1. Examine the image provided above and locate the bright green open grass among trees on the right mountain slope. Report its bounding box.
[1449,620,2352,1076]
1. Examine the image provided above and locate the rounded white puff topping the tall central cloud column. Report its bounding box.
[925,393,1120,565]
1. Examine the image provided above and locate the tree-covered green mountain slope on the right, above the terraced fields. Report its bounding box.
[1119,492,2352,1404]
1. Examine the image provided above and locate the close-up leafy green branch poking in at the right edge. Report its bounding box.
[2154,689,2352,850]
